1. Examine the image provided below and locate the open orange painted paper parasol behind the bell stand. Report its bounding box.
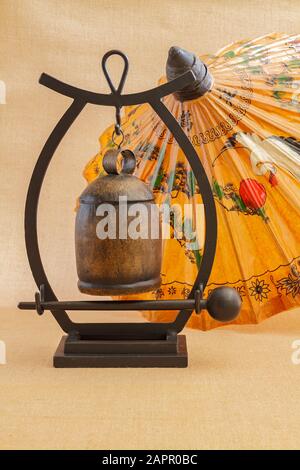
[84,34,300,330]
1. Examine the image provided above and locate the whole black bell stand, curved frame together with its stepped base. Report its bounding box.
[18,51,217,367]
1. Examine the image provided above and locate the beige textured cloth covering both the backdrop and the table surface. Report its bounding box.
[0,0,300,449]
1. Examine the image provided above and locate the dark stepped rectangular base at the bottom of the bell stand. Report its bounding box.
[53,335,188,368]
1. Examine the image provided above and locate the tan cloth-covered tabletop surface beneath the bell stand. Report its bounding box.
[0,309,300,449]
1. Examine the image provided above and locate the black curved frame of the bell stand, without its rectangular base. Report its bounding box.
[19,51,217,368]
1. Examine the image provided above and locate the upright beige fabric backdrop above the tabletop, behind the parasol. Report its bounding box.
[0,0,300,306]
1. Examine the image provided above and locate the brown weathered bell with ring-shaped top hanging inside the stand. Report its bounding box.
[75,149,162,295]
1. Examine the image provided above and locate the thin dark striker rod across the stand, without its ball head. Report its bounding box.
[18,299,206,311]
